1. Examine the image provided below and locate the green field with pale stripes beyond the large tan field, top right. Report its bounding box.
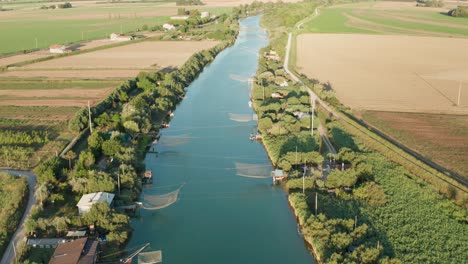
[303,2,468,37]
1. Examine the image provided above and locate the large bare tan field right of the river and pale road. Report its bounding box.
[297,34,468,114]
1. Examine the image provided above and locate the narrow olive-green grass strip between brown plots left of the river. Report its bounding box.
[0,79,120,90]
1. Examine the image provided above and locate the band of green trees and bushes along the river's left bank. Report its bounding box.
[14,11,238,263]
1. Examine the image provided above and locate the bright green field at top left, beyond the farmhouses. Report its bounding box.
[0,1,177,55]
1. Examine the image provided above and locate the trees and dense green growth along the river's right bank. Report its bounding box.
[244,3,468,263]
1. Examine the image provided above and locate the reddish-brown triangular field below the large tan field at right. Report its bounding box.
[362,111,468,179]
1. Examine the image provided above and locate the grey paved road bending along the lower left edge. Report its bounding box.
[0,170,36,264]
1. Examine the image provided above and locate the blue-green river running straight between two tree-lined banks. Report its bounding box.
[128,16,314,264]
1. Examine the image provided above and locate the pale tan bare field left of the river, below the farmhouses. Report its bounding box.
[0,41,218,79]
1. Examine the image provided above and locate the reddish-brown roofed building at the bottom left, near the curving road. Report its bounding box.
[49,237,98,264]
